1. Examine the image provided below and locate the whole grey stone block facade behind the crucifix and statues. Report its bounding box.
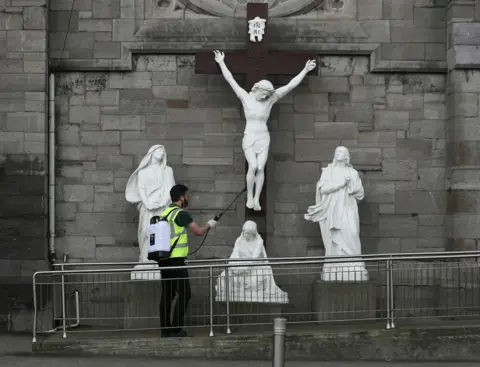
[0,0,480,336]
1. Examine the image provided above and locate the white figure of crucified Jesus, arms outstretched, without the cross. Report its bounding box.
[214,51,316,211]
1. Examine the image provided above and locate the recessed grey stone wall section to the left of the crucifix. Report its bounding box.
[56,55,245,261]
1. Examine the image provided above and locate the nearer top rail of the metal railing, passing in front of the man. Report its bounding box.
[33,253,480,277]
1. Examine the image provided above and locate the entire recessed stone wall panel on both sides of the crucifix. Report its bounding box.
[56,55,446,261]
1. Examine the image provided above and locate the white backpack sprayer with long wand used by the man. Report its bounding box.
[148,188,247,261]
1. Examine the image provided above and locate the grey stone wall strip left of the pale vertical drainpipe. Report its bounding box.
[0,0,48,328]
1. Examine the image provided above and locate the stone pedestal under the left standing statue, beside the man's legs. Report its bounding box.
[124,280,162,329]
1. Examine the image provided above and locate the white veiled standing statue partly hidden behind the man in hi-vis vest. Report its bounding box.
[125,145,175,262]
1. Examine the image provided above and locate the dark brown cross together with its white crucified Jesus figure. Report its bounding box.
[195,2,318,241]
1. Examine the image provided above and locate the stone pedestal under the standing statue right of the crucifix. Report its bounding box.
[312,280,377,321]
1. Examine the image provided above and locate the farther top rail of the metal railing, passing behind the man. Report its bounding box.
[49,251,480,267]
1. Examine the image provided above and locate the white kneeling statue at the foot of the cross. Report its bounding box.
[215,220,288,303]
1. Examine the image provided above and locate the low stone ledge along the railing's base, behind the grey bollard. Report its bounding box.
[32,320,480,362]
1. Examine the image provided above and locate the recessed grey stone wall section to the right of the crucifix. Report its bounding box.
[270,57,446,256]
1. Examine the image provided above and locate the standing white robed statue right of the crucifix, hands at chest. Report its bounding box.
[305,147,368,282]
